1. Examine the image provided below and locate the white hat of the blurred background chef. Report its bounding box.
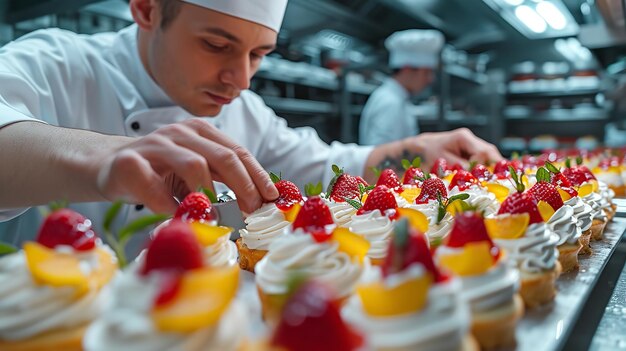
[385,29,445,68]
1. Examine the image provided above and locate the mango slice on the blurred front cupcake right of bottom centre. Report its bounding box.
[357,274,432,317]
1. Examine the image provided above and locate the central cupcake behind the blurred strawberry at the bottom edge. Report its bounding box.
[255,196,369,324]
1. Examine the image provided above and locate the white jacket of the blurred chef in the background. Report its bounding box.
[359,78,419,145]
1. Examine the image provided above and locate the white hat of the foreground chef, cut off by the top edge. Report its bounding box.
[182,0,287,32]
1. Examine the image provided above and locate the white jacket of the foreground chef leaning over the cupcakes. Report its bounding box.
[0,25,372,250]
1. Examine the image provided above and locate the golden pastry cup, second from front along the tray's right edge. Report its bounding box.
[520,261,562,308]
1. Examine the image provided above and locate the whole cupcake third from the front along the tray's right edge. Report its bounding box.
[528,167,583,272]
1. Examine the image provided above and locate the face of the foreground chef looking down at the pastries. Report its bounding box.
[138,2,277,116]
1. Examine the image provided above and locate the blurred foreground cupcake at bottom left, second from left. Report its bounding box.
[83,220,247,351]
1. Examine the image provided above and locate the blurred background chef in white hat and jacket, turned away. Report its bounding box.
[359,29,444,145]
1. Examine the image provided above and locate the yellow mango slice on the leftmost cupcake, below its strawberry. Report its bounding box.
[24,242,89,292]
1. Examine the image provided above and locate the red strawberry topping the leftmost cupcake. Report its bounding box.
[37,208,97,251]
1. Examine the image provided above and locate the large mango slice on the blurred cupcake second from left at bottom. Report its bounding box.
[152,266,239,333]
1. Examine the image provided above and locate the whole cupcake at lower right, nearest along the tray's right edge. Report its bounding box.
[435,211,524,350]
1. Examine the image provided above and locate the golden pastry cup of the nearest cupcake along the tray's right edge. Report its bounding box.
[472,294,524,350]
